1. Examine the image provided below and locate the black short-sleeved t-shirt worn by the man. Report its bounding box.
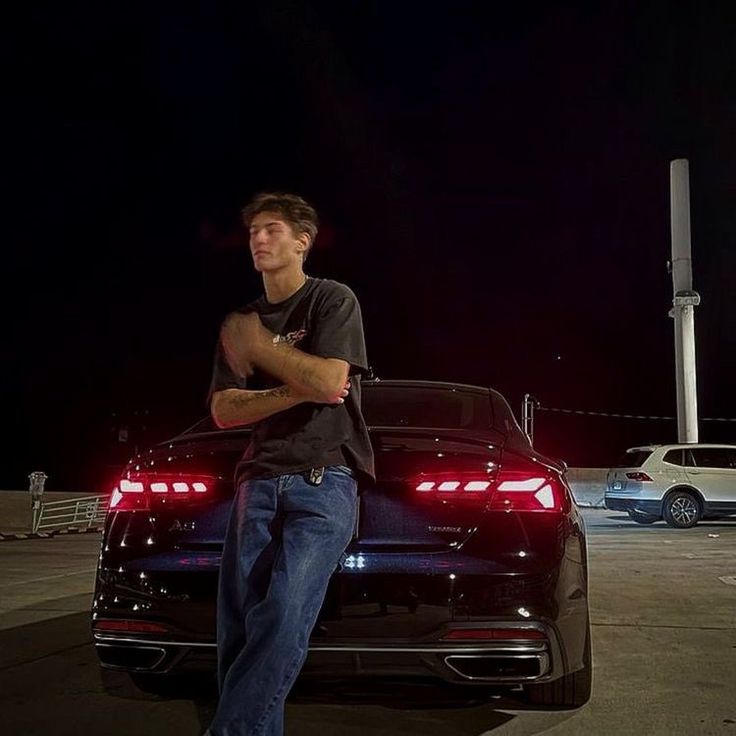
[210,277,375,483]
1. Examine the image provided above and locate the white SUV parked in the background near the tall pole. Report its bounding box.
[606,444,736,529]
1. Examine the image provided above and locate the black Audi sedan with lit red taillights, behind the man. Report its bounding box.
[92,381,592,707]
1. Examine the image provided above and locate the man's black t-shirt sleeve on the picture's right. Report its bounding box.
[309,284,368,373]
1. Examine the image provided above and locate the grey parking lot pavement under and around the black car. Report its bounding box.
[0,509,736,736]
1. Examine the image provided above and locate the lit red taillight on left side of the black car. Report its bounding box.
[110,473,215,511]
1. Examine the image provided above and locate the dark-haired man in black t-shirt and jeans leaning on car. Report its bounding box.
[208,193,374,736]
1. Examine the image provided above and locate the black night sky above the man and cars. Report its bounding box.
[5,0,736,491]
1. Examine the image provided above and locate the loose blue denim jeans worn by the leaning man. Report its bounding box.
[208,465,357,736]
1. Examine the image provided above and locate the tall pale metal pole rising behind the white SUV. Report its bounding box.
[670,158,700,442]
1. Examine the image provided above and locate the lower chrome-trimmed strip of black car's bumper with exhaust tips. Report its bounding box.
[94,622,566,686]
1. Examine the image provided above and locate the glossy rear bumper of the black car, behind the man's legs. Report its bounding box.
[92,517,589,685]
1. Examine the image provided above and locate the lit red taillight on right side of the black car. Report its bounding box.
[414,465,566,511]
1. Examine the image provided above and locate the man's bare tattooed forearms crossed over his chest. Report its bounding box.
[210,313,350,428]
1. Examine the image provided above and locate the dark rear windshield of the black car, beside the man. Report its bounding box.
[363,386,491,429]
